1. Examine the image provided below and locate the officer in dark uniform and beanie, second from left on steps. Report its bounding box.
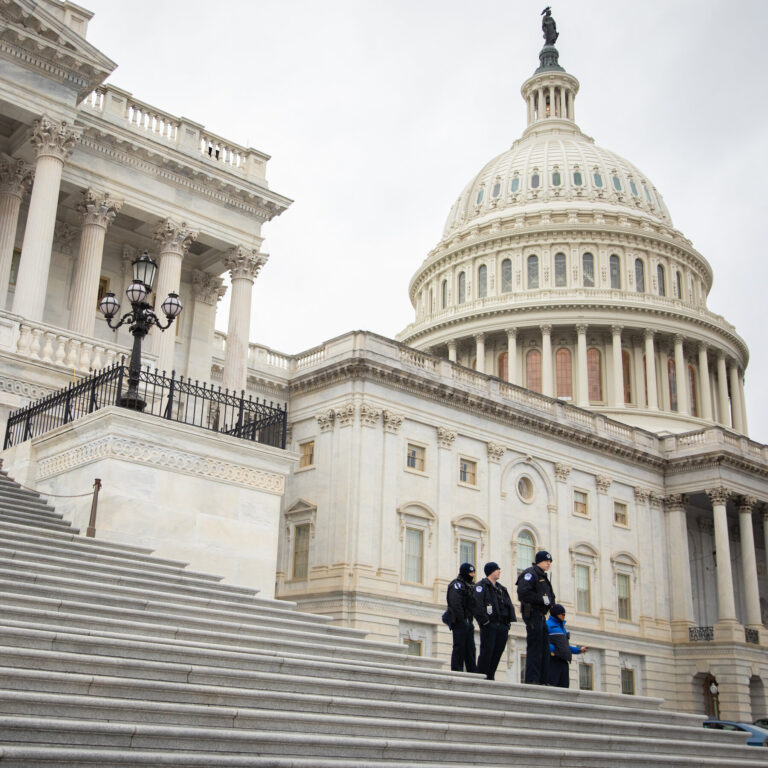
[474,562,517,680]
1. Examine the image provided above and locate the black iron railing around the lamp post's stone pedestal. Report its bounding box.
[3,361,287,448]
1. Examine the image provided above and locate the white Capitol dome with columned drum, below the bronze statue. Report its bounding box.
[398,37,749,433]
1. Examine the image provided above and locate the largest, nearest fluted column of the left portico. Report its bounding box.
[13,115,80,320]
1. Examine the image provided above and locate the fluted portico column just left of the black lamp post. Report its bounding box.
[69,189,121,336]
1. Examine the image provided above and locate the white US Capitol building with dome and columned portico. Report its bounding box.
[0,0,768,720]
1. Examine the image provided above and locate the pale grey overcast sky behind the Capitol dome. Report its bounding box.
[81,0,768,442]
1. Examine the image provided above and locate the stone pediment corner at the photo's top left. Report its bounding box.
[0,0,117,103]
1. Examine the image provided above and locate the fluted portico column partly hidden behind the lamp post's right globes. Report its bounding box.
[150,219,198,373]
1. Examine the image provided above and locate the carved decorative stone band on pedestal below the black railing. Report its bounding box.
[38,435,285,495]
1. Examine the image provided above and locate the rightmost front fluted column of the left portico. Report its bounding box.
[223,246,269,392]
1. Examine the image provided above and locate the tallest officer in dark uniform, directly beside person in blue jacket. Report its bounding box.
[517,550,556,685]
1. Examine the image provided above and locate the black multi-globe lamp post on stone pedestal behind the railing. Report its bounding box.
[99,251,183,411]
